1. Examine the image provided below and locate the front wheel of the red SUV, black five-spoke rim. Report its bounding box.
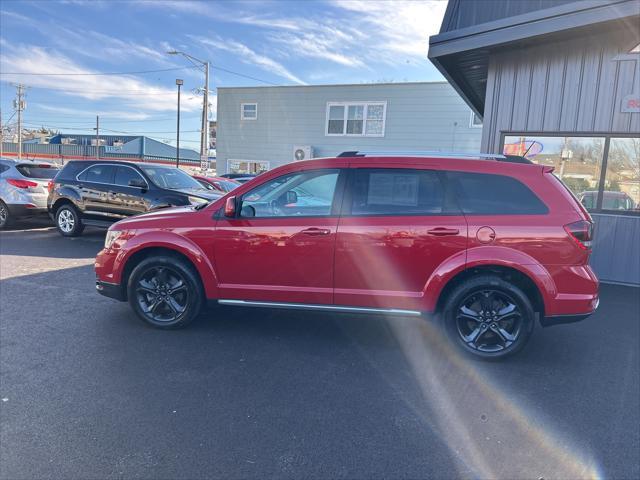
[127,255,204,330]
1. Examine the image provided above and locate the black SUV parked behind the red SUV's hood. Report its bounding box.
[47,160,221,237]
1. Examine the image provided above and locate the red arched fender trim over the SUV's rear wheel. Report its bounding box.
[423,246,558,311]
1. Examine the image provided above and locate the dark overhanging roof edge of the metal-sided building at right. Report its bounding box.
[429,0,640,116]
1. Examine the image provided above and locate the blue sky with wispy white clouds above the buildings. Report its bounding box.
[0,0,446,150]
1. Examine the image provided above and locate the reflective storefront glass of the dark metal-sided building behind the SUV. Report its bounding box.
[503,134,640,213]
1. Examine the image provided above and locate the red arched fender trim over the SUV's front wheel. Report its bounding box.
[113,230,218,298]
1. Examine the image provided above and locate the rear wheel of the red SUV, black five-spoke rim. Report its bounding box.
[442,275,535,360]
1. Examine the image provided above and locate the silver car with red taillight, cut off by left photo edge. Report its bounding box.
[0,158,58,229]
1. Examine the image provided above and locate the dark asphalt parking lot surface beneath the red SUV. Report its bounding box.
[0,222,640,479]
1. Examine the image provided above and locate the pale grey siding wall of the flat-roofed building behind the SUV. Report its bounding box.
[216,82,481,173]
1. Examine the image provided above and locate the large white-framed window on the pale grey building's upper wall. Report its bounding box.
[325,102,387,137]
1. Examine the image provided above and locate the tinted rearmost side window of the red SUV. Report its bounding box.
[448,172,549,215]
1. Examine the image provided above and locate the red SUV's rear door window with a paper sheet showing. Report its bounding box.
[351,168,446,215]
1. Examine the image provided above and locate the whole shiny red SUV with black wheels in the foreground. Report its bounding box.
[95,152,598,357]
